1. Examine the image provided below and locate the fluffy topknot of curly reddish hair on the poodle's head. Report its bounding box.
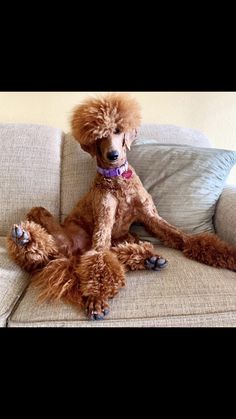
[71,93,141,145]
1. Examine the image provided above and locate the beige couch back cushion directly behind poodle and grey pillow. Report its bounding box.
[61,124,211,220]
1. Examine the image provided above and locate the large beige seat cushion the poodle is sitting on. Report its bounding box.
[9,246,236,327]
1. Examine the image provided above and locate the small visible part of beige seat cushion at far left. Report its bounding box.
[0,237,30,327]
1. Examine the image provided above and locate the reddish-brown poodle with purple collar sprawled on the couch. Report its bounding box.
[8,94,236,319]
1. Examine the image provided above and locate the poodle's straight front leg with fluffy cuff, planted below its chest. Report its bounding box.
[77,192,125,320]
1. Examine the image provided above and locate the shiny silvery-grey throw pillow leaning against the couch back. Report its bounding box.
[128,144,236,242]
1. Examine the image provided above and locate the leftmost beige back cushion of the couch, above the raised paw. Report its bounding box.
[0,124,63,235]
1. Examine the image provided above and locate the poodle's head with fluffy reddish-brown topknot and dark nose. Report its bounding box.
[71,93,141,168]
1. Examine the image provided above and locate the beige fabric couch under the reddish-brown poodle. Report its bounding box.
[0,124,236,327]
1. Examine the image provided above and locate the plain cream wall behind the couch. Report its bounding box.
[0,92,236,150]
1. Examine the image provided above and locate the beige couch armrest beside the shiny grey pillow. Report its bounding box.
[214,186,236,245]
